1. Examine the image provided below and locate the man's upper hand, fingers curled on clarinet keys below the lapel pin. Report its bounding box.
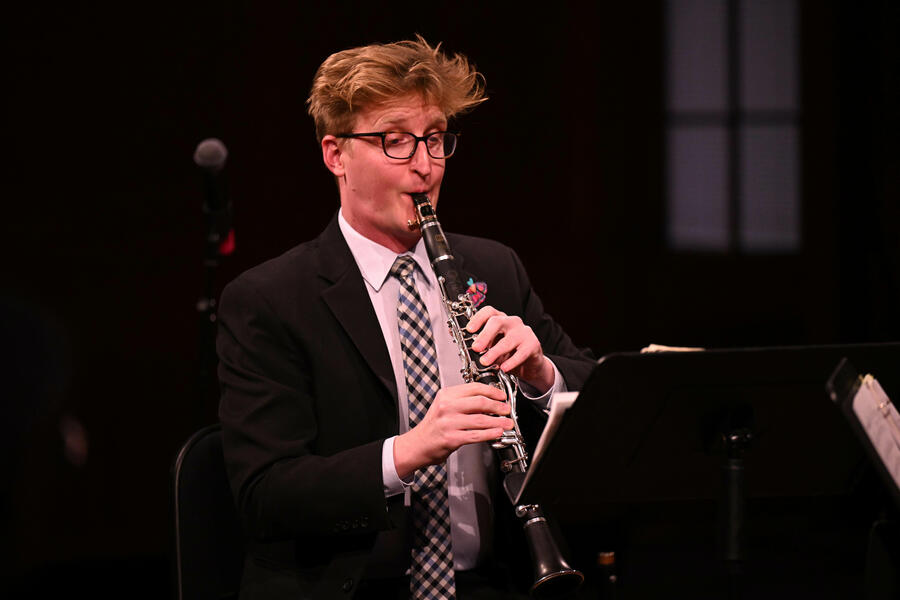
[466,306,555,394]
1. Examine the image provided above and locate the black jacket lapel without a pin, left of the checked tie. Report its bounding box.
[319,216,397,408]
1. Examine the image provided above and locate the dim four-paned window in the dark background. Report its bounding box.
[663,0,801,254]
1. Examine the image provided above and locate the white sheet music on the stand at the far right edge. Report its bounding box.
[853,375,900,487]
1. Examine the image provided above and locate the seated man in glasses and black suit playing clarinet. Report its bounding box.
[218,38,594,598]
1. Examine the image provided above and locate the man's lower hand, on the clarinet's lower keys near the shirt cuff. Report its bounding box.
[394,383,513,479]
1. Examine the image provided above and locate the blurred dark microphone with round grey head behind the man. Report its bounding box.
[194,138,234,260]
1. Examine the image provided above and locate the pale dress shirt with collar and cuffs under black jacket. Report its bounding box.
[338,212,566,570]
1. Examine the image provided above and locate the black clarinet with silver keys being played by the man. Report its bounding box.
[409,194,584,598]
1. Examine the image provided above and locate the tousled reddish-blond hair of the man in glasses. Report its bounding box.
[306,35,487,141]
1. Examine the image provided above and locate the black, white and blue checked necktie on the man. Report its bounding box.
[391,256,456,600]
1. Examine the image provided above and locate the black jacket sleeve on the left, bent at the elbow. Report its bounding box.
[217,276,392,540]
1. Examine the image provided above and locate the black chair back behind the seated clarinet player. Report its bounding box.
[172,424,244,600]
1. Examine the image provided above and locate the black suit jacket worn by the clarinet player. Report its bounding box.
[217,217,595,598]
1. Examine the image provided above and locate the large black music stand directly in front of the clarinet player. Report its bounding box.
[519,343,900,596]
